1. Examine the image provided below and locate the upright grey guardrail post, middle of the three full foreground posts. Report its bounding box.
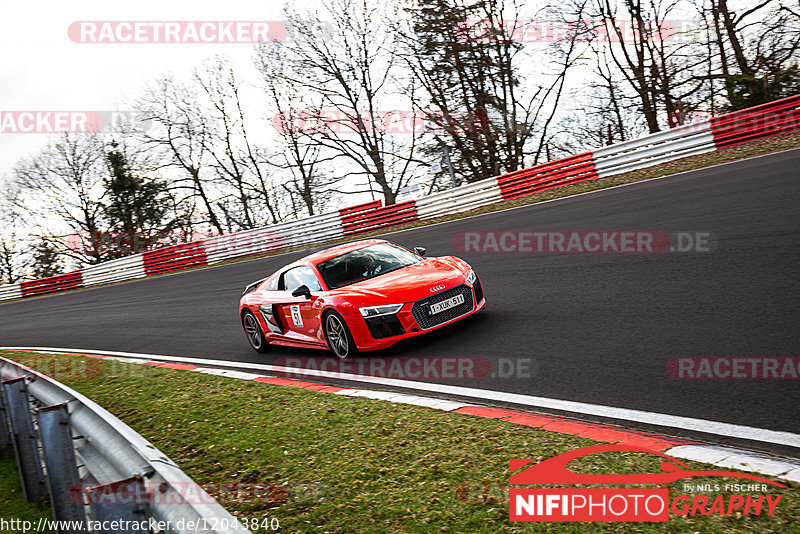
[36,403,86,534]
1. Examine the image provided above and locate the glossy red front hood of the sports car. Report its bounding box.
[334,256,470,304]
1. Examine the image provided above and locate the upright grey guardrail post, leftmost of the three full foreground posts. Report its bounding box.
[3,377,47,501]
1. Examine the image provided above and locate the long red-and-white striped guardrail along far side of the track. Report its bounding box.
[0,95,800,301]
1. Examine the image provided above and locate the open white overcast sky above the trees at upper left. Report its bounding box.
[0,0,290,184]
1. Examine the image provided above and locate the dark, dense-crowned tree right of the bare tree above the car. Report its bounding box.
[397,0,582,181]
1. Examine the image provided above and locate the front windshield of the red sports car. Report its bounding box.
[317,243,422,289]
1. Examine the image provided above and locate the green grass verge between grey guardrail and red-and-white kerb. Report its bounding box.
[0,353,800,533]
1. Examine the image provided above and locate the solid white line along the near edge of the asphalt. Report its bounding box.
[6,347,800,448]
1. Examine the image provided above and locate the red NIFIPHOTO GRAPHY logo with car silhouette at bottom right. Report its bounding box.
[509,445,786,522]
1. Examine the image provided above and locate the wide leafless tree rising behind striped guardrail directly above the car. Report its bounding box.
[270,0,417,204]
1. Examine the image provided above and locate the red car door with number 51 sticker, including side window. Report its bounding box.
[275,265,322,344]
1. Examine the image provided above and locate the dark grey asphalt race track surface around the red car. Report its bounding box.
[0,150,800,456]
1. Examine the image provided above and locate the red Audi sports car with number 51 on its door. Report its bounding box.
[239,239,486,358]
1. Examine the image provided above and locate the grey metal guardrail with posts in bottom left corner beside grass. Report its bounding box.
[0,358,249,534]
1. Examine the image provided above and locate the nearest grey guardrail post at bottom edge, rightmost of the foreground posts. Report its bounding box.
[86,476,151,534]
